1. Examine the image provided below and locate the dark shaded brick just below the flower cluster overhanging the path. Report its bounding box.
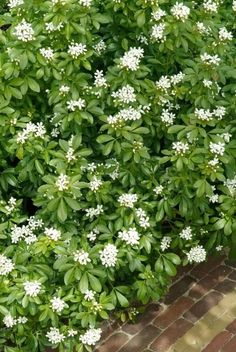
[164,275,196,304]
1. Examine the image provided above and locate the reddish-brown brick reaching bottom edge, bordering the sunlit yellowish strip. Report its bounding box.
[150,318,193,352]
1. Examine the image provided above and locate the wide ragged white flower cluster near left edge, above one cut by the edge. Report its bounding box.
[10,216,43,244]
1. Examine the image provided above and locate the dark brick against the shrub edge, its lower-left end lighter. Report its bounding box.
[122,303,163,335]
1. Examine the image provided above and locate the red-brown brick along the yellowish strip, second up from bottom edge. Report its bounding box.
[184,291,223,323]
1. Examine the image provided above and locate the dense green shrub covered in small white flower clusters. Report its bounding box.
[0,0,236,352]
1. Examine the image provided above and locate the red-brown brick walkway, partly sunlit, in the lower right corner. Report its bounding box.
[95,257,236,352]
